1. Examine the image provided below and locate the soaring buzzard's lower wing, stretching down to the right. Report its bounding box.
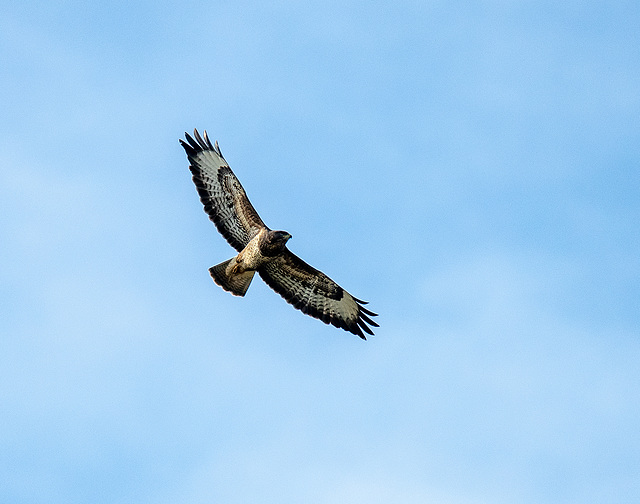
[258,249,378,339]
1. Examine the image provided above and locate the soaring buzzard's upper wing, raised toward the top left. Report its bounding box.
[180,130,265,252]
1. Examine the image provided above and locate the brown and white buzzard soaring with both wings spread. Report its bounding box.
[180,130,378,339]
